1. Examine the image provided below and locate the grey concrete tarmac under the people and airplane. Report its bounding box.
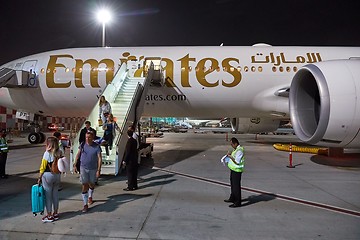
[0,132,360,240]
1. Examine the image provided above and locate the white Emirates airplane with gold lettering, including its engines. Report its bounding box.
[0,44,360,157]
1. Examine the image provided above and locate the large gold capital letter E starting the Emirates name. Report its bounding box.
[46,54,73,88]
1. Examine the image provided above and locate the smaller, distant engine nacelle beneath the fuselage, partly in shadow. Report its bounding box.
[230,118,280,133]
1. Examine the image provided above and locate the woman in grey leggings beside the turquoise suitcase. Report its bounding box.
[38,137,61,222]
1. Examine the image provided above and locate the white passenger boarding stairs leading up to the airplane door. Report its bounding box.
[70,62,162,175]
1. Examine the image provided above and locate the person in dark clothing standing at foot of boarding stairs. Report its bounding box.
[123,130,138,191]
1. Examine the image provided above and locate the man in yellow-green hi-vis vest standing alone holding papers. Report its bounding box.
[224,137,245,208]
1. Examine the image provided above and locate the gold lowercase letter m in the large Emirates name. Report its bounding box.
[75,59,114,88]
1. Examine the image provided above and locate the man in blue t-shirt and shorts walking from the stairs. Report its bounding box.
[73,131,102,213]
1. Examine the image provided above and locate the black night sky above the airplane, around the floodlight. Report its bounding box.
[0,0,360,64]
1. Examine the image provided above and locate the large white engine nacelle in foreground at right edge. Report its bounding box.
[289,59,360,148]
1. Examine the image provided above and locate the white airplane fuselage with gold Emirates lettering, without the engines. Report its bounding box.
[0,46,360,118]
